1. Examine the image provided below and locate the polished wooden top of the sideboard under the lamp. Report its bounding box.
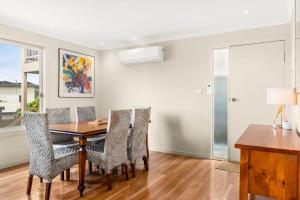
[235,124,300,154]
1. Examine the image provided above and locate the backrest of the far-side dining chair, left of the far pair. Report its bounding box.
[46,108,73,144]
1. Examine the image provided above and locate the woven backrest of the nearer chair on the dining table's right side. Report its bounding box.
[105,110,131,171]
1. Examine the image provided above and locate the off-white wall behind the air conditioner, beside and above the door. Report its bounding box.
[97,25,291,157]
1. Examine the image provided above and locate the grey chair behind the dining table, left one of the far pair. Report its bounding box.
[46,108,78,149]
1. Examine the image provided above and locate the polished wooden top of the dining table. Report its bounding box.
[49,122,107,136]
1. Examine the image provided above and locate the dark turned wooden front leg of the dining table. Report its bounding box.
[78,137,87,197]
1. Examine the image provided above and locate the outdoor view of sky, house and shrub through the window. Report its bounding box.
[0,44,40,128]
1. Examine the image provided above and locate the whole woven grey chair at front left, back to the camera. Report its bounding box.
[24,112,78,200]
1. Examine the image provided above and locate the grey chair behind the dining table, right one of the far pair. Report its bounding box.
[75,106,105,173]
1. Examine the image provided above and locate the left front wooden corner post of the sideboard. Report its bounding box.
[240,149,249,200]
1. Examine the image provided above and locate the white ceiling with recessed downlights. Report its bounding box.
[0,0,292,49]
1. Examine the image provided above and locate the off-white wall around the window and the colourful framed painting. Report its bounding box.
[0,25,100,168]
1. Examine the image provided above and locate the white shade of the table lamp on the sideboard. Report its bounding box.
[267,88,296,105]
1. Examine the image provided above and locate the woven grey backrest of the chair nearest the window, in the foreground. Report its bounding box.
[24,112,54,178]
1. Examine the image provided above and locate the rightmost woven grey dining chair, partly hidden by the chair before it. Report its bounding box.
[128,107,151,177]
